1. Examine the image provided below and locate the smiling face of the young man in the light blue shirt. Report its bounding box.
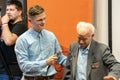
[29,12,46,32]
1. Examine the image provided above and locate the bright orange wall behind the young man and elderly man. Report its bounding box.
[27,0,92,53]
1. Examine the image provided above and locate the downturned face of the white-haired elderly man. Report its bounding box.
[78,27,94,48]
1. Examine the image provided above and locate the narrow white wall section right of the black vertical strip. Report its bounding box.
[112,0,120,61]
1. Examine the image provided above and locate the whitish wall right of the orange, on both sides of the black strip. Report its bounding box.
[93,0,120,61]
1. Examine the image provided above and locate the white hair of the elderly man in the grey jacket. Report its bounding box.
[77,22,95,34]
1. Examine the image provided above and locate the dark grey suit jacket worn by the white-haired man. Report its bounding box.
[63,40,120,80]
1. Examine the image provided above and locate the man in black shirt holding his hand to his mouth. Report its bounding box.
[0,0,27,80]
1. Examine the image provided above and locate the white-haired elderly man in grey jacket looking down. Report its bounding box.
[63,22,120,80]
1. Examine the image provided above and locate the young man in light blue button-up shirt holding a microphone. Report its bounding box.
[15,5,66,80]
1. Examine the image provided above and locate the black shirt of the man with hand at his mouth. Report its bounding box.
[0,21,27,75]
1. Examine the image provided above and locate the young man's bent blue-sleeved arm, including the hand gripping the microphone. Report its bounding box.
[15,37,57,73]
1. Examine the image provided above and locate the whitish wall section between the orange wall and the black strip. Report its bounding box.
[93,0,108,45]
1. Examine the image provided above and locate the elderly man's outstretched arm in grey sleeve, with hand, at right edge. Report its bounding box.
[103,48,120,80]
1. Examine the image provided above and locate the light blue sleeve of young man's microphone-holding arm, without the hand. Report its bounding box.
[15,38,47,73]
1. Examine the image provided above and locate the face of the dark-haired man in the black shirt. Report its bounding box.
[6,5,22,20]
